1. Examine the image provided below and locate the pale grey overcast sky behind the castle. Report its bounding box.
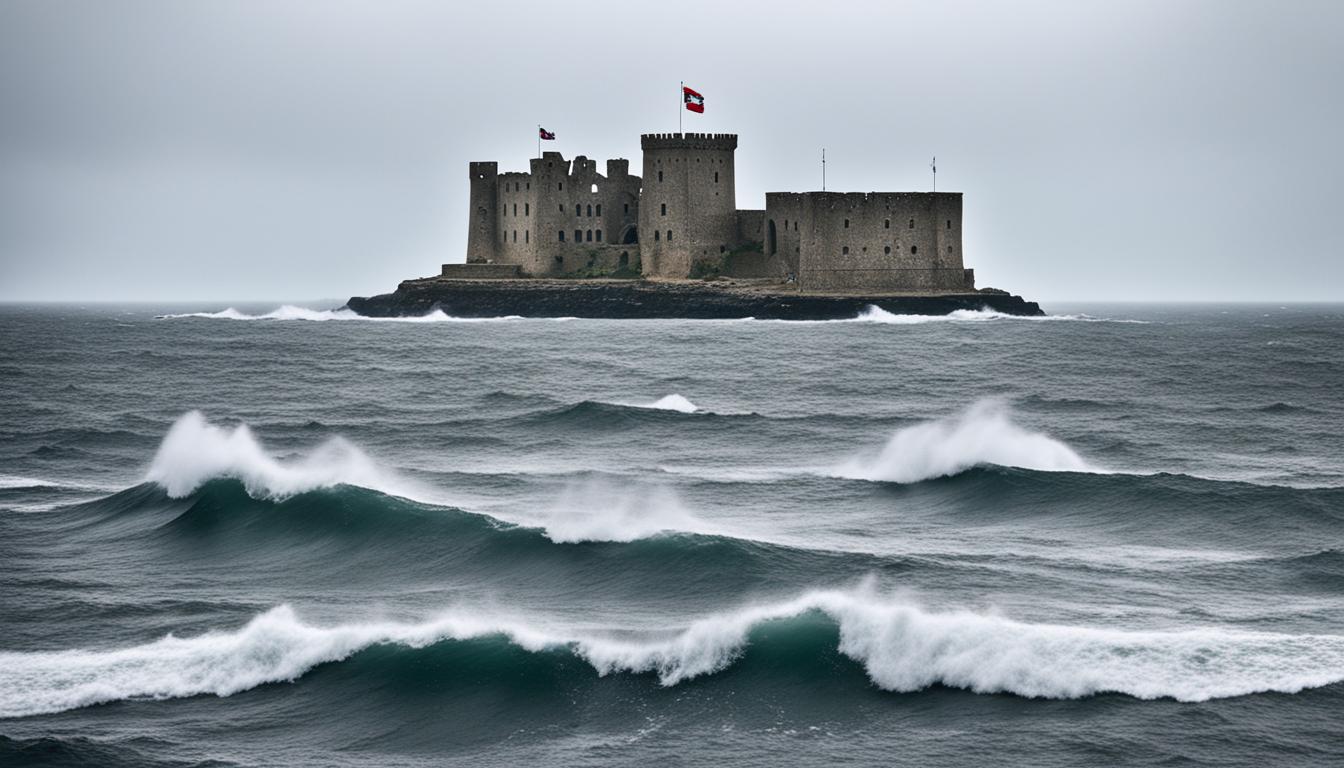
[0,0,1344,301]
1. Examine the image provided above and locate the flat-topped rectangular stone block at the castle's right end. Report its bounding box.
[790,192,966,292]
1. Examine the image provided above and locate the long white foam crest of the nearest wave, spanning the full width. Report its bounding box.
[0,588,1344,717]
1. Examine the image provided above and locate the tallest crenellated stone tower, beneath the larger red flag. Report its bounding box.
[638,133,738,278]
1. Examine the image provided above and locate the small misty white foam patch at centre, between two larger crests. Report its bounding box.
[516,477,722,543]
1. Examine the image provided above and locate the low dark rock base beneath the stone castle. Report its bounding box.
[347,278,1044,320]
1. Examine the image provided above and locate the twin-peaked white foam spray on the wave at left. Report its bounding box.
[145,410,418,499]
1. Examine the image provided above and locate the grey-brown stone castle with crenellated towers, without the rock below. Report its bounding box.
[454,133,974,293]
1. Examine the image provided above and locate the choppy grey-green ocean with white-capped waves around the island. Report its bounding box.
[0,304,1344,768]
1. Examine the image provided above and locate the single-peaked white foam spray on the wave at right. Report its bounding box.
[829,399,1103,483]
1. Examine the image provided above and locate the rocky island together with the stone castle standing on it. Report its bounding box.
[347,133,1043,320]
